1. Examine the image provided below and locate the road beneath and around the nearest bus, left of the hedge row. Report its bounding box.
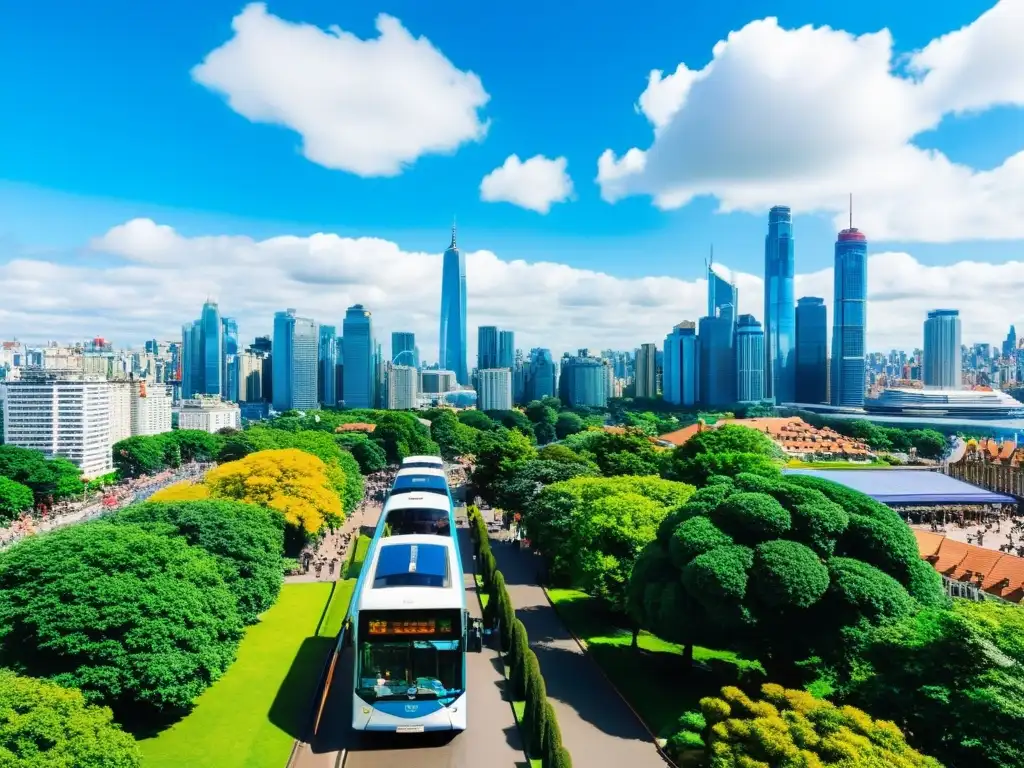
[292,520,525,768]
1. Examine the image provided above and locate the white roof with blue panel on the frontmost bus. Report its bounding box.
[356,534,466,610]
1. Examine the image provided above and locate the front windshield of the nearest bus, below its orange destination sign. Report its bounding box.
[355,640,463,702]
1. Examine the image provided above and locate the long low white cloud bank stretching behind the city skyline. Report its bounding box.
[0,219,1024,360]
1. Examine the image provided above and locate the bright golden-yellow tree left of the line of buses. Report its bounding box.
[200,449,344,534]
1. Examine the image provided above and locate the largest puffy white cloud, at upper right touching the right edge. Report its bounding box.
[597,0,1024,242]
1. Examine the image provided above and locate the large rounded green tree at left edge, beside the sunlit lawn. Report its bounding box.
[0,522,242,722]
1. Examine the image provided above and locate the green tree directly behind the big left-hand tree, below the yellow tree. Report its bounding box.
[113,501,285,624]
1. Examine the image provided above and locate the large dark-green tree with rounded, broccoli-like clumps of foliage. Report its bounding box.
[628,474,944,673]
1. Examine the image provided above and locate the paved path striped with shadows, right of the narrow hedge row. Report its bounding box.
[490,537,666,768]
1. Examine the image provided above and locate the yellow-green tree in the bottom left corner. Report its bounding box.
[0,670,142,768]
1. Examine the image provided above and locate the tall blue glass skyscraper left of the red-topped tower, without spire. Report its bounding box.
[764,206,797,402]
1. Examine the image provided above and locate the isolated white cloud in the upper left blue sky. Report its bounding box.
[191,3,489,176]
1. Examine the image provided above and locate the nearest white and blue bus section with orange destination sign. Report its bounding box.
[349,536,479,733]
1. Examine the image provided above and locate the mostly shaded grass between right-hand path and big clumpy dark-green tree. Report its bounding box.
[548,589,757,738]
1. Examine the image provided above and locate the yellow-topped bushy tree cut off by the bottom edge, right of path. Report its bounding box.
[700,683,941,768]
